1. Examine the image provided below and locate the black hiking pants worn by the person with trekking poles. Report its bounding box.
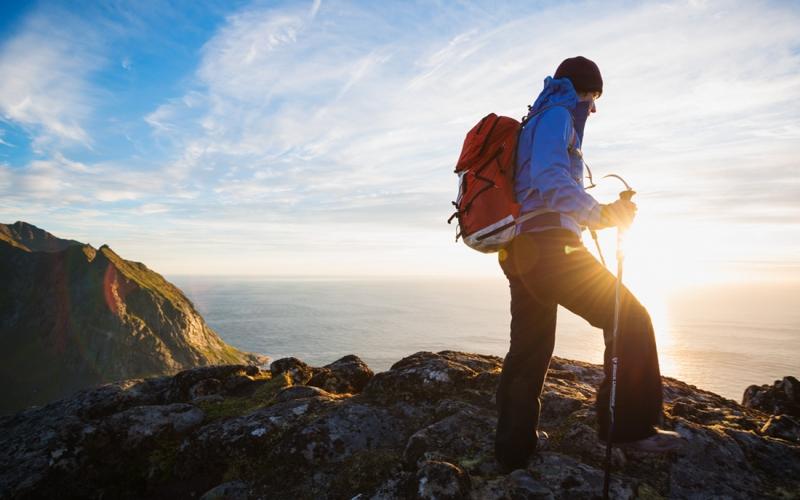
[495,229,663,465]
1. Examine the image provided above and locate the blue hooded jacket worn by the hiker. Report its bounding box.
[514,76,600,237]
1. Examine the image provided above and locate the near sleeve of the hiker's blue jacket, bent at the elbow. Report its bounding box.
[530,107,600,227]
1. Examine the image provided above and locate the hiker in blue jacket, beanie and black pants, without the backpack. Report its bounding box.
[495,56,681,470]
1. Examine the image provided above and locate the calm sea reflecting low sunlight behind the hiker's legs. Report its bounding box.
[170,276,800,401]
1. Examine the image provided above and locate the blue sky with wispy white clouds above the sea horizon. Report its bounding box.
[0,0,800,287]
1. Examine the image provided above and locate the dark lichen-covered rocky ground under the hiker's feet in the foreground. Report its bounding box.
[0,351,800,500]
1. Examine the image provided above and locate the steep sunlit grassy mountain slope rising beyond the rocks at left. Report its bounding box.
[0,222,266,413]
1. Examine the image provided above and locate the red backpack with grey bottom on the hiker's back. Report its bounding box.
[447,113,522,253]
